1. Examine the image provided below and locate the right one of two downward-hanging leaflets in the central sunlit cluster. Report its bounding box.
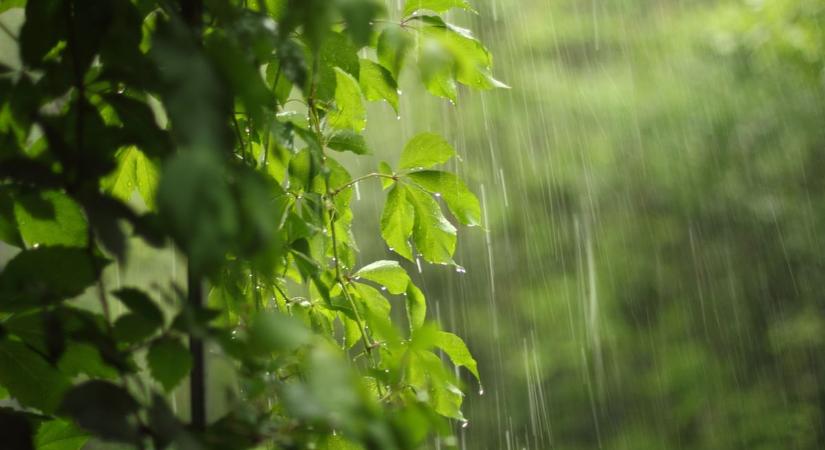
[407,189,456,264]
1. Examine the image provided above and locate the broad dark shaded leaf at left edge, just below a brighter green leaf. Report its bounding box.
[0,247,99,312]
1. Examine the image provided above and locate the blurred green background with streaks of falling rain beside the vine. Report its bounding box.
[362,0,825,450]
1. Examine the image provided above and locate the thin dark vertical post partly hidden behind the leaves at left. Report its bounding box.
[180,0,206,431]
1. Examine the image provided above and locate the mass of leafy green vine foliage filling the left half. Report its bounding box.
[0,0,504,450]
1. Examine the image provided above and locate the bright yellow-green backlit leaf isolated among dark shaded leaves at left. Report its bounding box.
[101,147,160,210]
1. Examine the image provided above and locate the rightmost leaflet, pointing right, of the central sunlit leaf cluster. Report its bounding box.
[406,170,481,226]
